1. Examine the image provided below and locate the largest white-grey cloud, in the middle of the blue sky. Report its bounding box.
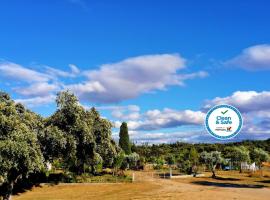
[67,54,207,103]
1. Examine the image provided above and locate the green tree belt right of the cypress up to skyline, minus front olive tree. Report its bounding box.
[133,139,270,170]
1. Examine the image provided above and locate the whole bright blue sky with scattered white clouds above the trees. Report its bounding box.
[0,0,270,143]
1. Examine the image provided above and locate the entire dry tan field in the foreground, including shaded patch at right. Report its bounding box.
[13,171,270,200]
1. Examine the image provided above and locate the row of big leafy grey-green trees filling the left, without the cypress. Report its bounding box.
[0,91,135,199]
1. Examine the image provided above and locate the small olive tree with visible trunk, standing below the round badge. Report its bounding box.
[200,151,223,178]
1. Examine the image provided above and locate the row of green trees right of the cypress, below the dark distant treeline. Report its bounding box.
[133,144,270,177]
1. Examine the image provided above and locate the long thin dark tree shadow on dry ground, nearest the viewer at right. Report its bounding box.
[192,181,265,188]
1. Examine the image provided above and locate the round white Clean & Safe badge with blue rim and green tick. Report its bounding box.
[205,105,243,140]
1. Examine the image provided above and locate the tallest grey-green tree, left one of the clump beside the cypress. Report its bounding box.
[47,91,95,174]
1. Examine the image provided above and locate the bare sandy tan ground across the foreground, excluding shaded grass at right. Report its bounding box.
[13,174,270,200]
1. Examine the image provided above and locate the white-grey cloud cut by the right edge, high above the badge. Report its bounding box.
[225,44,270,70]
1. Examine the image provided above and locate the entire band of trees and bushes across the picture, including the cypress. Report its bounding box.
[0,91,270,200]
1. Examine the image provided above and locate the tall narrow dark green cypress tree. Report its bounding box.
[119,122,131,155]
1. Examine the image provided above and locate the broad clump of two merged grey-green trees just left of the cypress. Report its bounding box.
[46,91,119,174]
